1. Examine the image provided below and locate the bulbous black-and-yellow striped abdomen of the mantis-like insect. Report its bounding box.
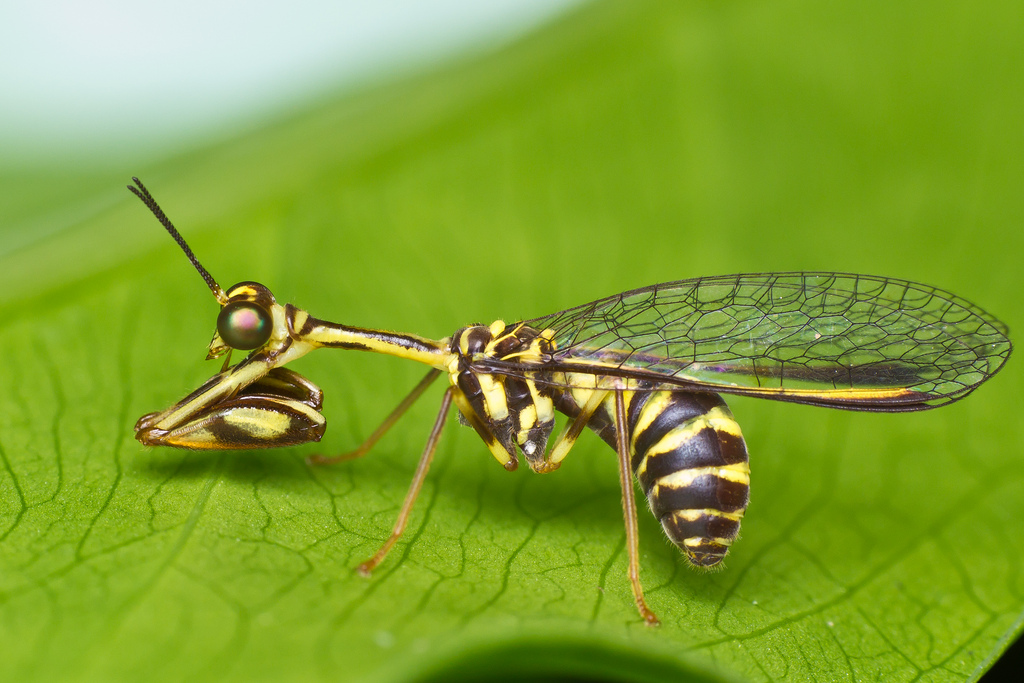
[629,391,751,567]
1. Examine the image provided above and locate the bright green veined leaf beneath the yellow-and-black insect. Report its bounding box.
[0,2,1024,681]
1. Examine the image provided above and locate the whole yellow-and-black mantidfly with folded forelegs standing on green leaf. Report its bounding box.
[128,178,1012,625]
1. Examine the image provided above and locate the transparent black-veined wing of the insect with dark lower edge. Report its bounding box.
[503,272,1011,411]
